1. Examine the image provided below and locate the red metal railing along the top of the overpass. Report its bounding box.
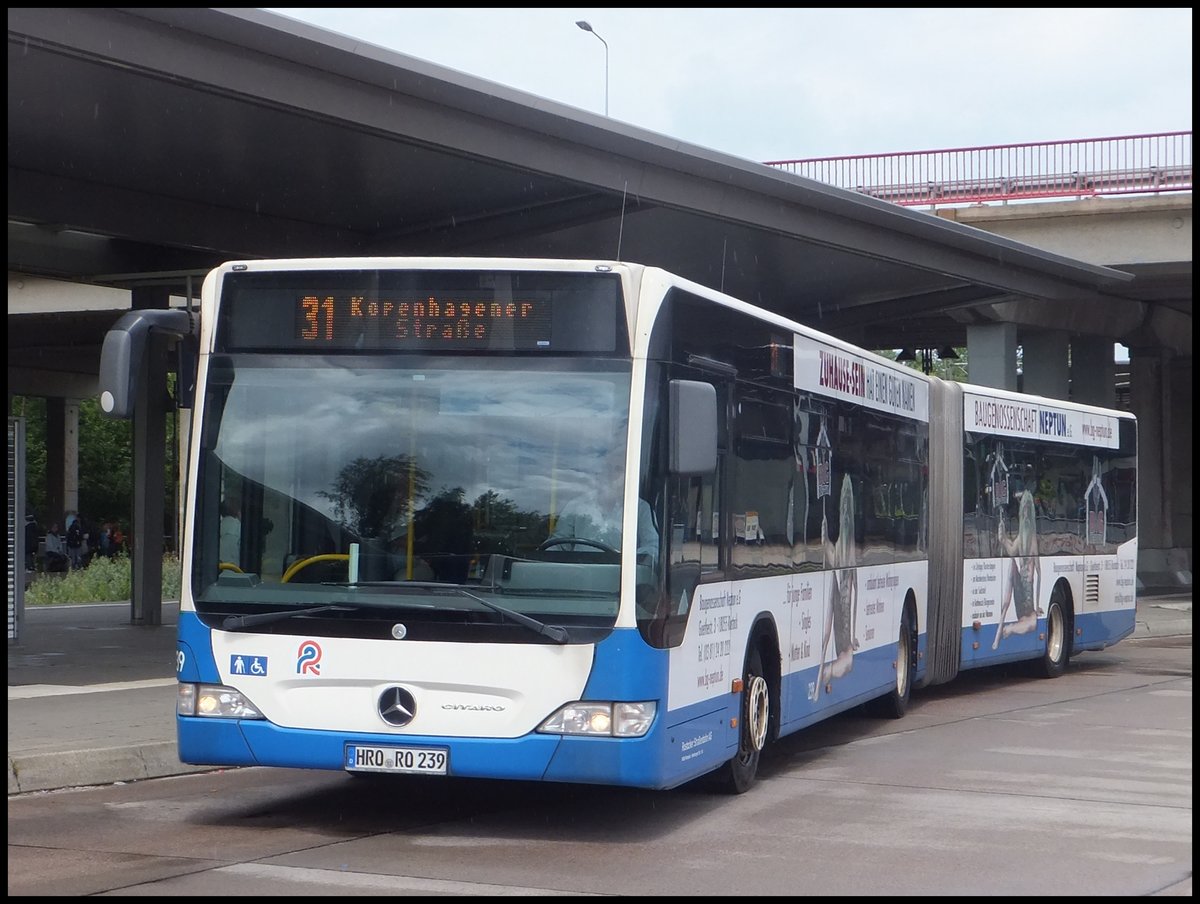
[767,132,1192,205]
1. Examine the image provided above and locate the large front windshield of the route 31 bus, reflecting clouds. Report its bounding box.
[192,354,630,625]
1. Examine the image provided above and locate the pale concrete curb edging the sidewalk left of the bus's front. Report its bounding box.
[8,741,226,795]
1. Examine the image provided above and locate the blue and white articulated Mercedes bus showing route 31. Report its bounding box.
[101,258,1138,792]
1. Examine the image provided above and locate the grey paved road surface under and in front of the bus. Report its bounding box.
[8,600,1193,896]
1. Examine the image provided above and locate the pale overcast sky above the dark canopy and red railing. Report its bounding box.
[269,7,1192,161]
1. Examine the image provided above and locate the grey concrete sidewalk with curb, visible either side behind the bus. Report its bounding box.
[8,588,1192,795]
